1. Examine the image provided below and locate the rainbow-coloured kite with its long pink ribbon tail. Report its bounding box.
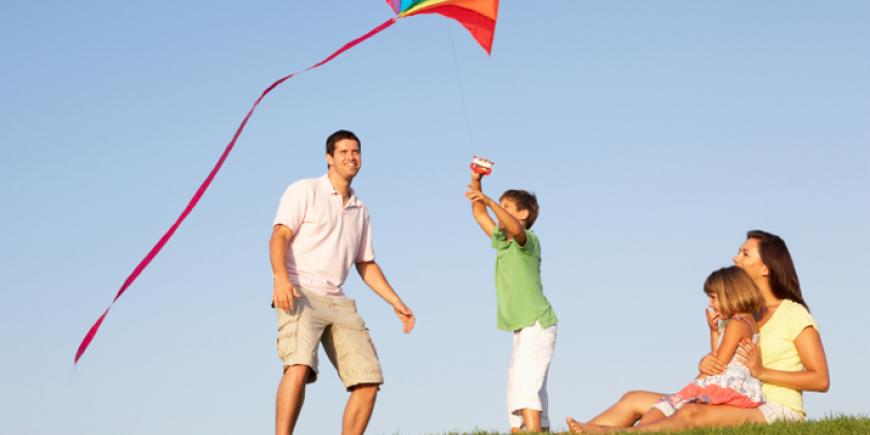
[73,0,498,364]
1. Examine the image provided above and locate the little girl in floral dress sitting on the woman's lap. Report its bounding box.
[640,266,764,424]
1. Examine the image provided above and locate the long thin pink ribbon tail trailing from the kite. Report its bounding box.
[73,17,396,364]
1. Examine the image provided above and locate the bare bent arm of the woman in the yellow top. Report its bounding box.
[737,326,831,393]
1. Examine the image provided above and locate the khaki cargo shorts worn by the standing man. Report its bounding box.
[275,287,384,389]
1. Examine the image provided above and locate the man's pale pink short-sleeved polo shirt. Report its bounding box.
[275,175,375,297]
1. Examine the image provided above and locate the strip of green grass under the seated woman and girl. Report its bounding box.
[447,416,870,435]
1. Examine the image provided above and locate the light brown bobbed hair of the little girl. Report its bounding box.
[704,266,764,318]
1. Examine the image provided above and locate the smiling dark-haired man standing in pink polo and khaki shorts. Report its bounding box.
[269,130,415,435]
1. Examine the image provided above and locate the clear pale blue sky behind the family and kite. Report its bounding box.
[0,0,870,434]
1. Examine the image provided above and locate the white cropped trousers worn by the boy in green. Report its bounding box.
[507,322,556,429]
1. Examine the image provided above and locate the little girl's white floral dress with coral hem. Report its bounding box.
[654,316,764,416]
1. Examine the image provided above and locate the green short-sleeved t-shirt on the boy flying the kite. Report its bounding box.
[492,229,558,331]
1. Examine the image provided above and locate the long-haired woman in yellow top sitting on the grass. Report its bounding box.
[567,230,830,432]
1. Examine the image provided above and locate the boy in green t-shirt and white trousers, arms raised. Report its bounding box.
[465,171,557,432]
